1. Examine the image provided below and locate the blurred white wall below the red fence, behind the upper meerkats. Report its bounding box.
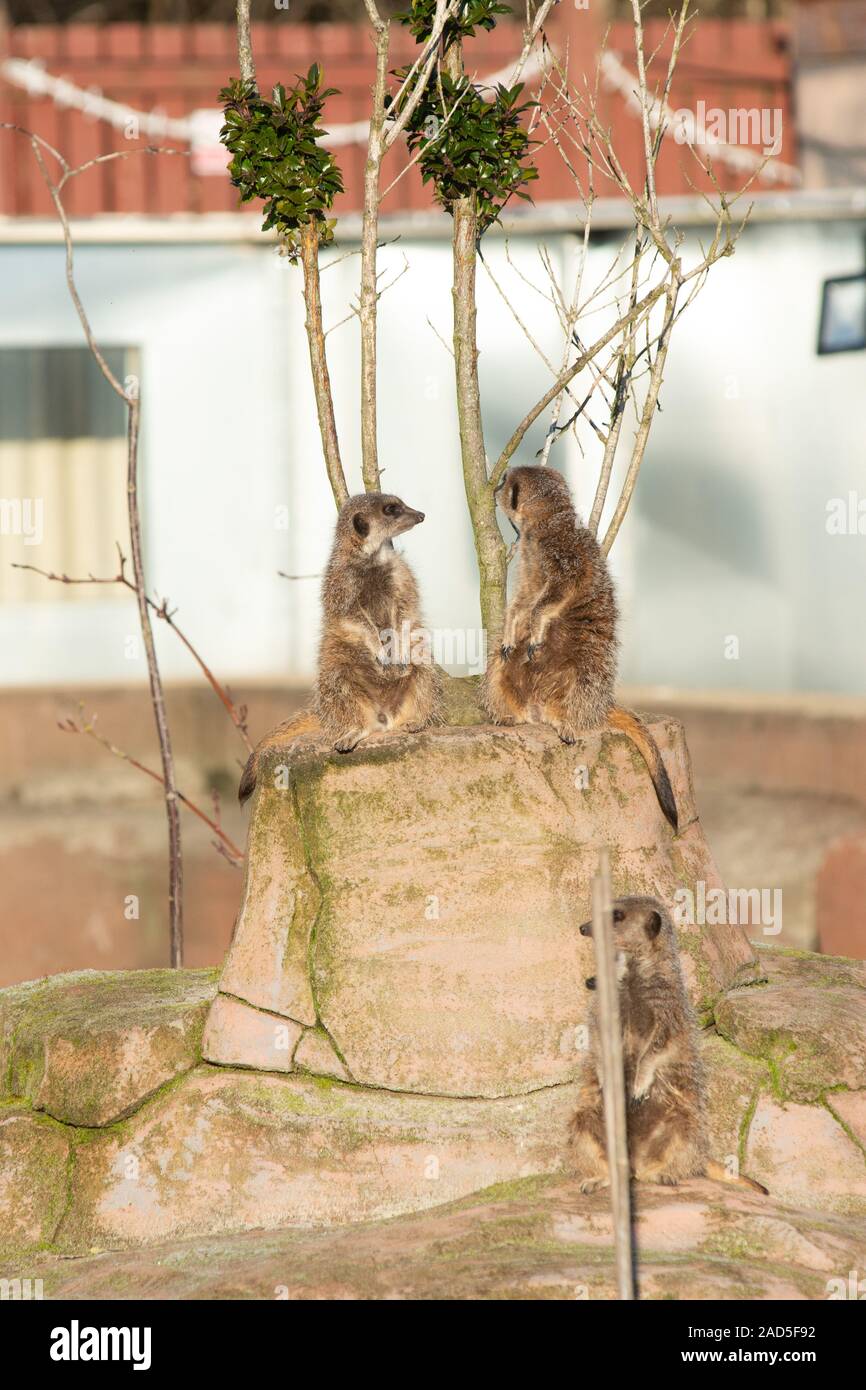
[0,214,866,692]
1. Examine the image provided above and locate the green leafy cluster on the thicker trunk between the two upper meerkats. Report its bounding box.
[395,72,538,236]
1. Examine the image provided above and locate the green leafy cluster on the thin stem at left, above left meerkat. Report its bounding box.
[220,64,343,260]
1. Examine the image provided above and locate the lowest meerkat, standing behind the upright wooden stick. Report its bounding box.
[570,898,767,1195]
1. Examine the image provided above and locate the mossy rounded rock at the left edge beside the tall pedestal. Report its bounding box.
[0,970,217,1126]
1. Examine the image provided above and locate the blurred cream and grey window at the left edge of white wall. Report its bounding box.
[0,348,135,603]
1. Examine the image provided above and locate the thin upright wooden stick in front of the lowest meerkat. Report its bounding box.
[592,849,635,1301]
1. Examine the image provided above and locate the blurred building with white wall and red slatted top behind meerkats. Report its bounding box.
[0,6,866,692]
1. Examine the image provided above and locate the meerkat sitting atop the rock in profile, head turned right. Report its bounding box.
[238,492,439,803]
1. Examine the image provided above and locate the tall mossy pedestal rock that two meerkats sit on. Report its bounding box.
[204,720,758,1098]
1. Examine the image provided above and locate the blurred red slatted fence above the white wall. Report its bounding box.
[0,15,795,215]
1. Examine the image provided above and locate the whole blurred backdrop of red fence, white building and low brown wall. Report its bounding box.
[0,0,866,984]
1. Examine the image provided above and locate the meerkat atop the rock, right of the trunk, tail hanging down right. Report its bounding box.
[482,466,678,831]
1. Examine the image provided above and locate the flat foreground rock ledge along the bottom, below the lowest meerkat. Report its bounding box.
[18,1179,866,1301]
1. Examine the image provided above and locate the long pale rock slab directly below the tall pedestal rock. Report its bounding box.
[58,1066,577,1251]
